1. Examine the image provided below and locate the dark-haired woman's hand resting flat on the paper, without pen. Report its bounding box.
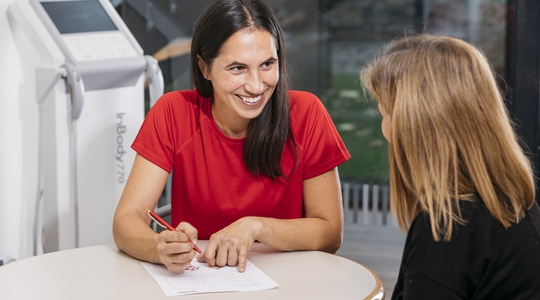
[197,217,260,272]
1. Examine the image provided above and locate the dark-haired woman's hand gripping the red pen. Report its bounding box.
[157,222,197,272]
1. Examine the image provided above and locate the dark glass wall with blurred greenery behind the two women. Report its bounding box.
[118,0,512,188]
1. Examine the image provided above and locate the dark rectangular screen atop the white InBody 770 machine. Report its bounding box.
[41,0,118,34]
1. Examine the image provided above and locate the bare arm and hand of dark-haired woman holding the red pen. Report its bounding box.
[113,154,197,272]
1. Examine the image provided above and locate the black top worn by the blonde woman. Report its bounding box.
[392,201,540,300]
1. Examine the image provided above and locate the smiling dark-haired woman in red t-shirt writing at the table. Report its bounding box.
[113,0,350,272]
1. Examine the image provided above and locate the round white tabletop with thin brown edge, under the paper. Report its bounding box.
[0,241,384,300]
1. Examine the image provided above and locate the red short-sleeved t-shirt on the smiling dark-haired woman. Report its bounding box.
[132,90,350,239]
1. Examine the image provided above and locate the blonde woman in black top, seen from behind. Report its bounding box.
[361,34,540,300]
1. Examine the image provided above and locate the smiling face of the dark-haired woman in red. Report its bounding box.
[199,28,279,138]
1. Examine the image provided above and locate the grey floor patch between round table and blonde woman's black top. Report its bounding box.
[337,224,406,299]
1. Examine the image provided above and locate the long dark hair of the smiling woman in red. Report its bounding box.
[191,0,298,179]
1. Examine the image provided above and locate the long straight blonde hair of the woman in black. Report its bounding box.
[360,34,535,241]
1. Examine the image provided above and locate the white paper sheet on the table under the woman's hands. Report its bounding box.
[141,258,278,296]
